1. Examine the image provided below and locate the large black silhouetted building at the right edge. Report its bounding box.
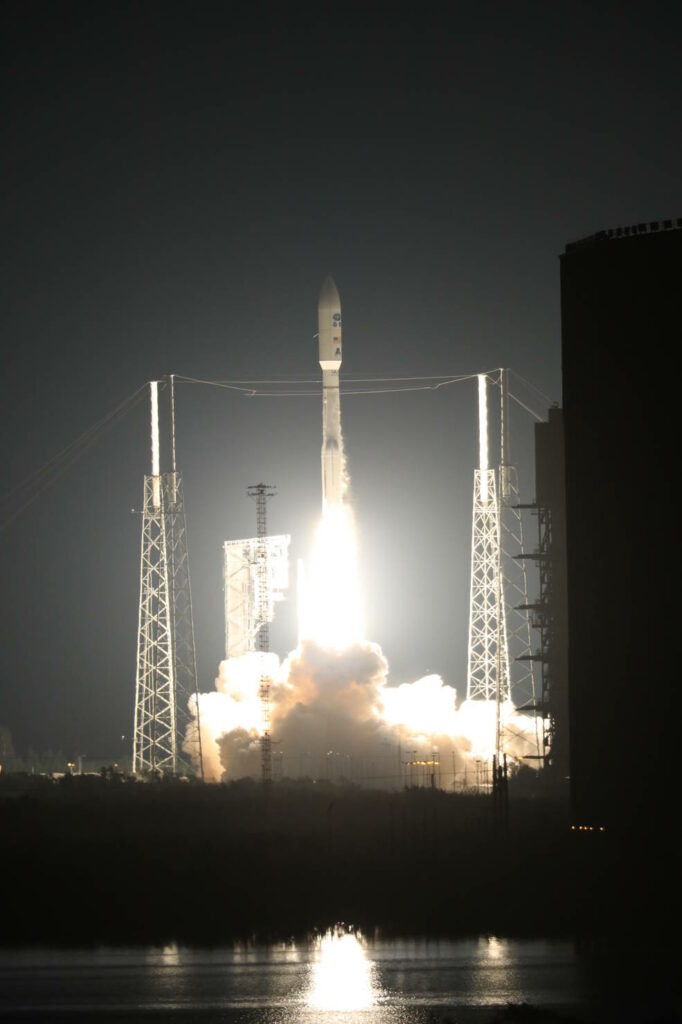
[561,218,682,827]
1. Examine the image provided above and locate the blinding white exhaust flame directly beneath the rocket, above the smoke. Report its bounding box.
[299,505,364,650]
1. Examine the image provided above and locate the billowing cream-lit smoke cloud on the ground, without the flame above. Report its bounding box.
[185,640,535,788]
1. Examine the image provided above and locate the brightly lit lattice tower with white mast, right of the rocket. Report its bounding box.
[467,374,510,753]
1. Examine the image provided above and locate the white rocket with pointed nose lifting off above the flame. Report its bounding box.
[317,278,343,510]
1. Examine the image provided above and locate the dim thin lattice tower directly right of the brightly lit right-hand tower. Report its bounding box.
[499,370,541,754]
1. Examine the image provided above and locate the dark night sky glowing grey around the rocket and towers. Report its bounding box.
[0,2,682,756]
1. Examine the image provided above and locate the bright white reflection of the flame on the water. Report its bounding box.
[308,929,375,1011]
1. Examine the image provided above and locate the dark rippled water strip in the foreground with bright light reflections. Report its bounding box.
[0,929,587,1024]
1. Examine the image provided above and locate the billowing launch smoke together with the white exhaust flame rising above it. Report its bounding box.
[184,440,536,790]
